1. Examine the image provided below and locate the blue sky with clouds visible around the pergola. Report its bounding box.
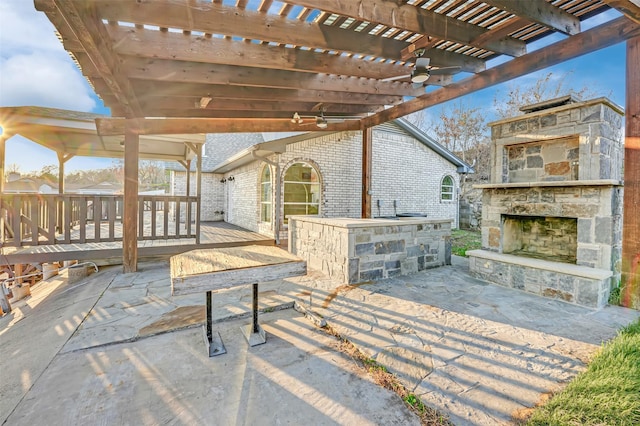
[0,0,625,173]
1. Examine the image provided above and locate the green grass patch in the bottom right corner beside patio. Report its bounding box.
[526,320,640,426]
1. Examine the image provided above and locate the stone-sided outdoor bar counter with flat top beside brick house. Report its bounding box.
[289,216,451,284]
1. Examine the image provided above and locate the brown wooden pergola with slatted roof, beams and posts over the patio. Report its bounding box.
[35,0,640,306]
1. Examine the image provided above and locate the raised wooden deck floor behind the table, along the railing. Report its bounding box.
[2,222,275,265]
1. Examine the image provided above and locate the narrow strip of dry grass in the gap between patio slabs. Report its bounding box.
[323,325,453,426]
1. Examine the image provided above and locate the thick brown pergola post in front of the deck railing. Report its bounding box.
[122,128,140,273]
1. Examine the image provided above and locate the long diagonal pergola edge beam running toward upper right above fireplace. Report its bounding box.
[363,17,640,127]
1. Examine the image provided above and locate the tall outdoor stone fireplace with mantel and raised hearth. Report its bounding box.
[469,97,624,308]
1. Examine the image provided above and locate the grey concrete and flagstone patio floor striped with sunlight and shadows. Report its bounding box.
[0,257,640,425]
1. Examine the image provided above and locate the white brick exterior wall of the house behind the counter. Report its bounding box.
[172,125,459,233]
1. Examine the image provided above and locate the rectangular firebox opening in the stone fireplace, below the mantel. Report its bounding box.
[502,215,578,264]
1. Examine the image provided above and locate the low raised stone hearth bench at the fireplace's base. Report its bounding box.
[467,250,613,309]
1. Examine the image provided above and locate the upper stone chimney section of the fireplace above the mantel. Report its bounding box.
[489,98,624,183]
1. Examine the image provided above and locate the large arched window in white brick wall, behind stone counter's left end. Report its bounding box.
[284,163,320,224]
